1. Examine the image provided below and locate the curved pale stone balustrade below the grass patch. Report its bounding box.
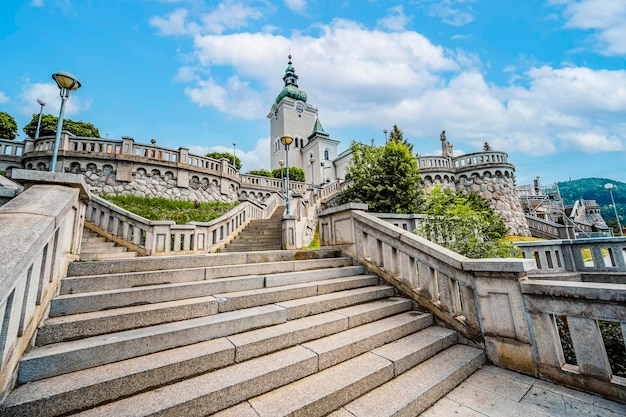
[85,194,282,255]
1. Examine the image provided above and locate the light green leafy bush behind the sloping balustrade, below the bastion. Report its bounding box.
[416,187,516,258]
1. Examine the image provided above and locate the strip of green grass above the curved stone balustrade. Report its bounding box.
[101,195,239,224]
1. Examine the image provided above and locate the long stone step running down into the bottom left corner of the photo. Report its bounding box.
[3,298,416,416]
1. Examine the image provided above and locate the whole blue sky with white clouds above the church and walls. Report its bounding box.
[0,0,626,185]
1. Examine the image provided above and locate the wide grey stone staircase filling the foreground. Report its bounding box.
[0,250,485,417]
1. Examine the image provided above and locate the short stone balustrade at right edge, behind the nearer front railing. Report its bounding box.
[515,237,626,276]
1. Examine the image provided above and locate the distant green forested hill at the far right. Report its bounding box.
[558,178,626,228]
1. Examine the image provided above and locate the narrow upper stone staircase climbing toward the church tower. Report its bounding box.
[219,206,285,252]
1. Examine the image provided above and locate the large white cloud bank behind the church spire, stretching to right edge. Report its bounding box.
[154,7,626,158]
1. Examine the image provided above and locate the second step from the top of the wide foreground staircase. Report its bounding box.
[60,258,364,295]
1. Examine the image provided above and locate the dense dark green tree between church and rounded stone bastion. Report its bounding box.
[338,140,422,213]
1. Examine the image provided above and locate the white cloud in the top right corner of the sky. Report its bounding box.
[553,0,626,55]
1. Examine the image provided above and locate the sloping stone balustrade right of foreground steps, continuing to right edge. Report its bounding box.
[319,204,626,402]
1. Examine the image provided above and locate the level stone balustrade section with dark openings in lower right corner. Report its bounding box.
[521,280,626,403]
